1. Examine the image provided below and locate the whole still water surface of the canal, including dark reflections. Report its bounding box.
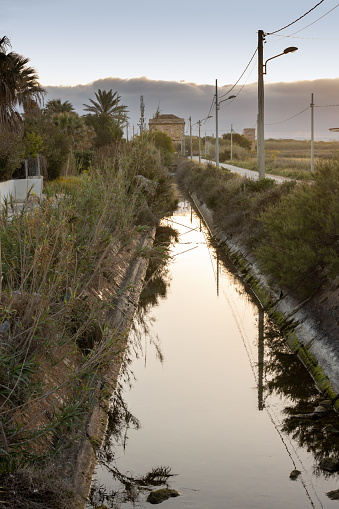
[88,195,339,509]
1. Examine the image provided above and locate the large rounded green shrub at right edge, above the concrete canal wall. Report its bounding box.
[257,161,339,296]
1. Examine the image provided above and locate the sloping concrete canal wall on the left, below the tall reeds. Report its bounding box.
[58,228,156,508]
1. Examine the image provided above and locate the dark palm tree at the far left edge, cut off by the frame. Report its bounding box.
[0,36,45,132]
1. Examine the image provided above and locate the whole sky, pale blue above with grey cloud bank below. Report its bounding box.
[0,0,339,139]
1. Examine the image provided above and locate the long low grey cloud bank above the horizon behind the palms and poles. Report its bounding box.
[45,77,339,141]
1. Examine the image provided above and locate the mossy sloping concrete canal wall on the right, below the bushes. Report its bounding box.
[188,191,339,411]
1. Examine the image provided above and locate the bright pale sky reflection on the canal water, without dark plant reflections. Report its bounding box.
[89,202,337,509]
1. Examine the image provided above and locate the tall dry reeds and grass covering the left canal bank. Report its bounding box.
[0,140,175,490]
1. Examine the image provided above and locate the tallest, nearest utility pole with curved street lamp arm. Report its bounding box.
[257,30,298,179]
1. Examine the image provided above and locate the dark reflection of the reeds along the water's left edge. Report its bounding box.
[87,225,178,508]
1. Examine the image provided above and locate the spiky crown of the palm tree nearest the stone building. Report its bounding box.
[84,88,128,127]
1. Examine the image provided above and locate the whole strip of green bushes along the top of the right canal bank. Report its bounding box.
[179,159,339,298]
